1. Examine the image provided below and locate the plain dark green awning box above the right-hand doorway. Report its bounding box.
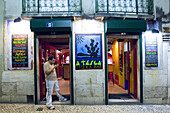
[105,19,146,34]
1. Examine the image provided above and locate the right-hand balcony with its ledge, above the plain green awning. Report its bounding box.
[96,0,154,18]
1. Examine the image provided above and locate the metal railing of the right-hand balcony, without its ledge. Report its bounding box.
[96,0,153,14]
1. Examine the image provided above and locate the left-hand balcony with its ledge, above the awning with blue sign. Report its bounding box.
[22,0,82,17]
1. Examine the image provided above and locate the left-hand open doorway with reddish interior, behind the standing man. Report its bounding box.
[37,35,71,104]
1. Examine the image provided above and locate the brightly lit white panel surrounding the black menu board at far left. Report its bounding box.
[7,20,34,70]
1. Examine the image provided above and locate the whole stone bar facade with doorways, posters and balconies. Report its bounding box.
[0,0,170,105]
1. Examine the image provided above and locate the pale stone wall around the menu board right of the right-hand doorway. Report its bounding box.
[143,34,169,104]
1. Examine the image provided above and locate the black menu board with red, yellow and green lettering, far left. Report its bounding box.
[12,35,28,68]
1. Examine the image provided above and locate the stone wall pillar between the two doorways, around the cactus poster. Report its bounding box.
[73,20,105,105]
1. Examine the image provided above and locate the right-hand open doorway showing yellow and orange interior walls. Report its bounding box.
[107,36,140,103]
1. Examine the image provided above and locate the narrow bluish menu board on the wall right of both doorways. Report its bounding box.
[145,36,158,67]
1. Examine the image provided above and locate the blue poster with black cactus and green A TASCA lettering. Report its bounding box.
[75,34,103,70]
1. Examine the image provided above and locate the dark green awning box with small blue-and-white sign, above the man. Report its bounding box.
[30,18,72,33]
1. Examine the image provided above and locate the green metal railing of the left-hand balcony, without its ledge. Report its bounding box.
[22,0,82,13]
